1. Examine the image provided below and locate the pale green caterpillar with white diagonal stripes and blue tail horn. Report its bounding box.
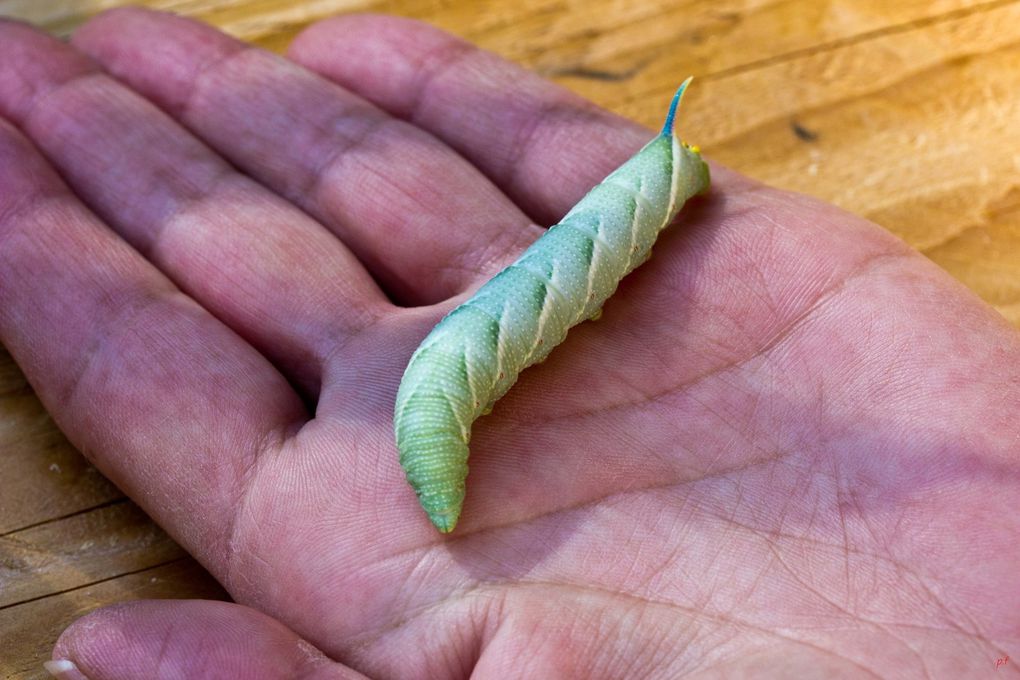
[394,79,709,533]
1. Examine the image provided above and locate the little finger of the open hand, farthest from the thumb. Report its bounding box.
[288,14,753,224]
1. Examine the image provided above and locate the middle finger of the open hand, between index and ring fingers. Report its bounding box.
[0,23,389,394]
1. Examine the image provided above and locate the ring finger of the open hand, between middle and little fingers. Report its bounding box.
[73,8,541,304]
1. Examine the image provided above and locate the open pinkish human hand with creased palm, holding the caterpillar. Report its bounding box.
[0,10,1020,680]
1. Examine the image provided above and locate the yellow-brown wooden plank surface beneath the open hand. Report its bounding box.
[0,0,1020,678]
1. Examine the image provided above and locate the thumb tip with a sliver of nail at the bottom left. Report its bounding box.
[46,599,364,680]
